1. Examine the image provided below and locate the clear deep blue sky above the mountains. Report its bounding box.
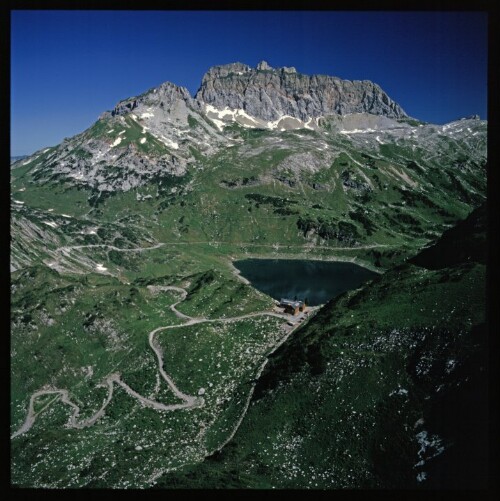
[11,11,487,155]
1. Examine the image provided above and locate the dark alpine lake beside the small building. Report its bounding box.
[233,259,377,306]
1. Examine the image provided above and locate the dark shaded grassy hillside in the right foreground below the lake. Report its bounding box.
[157,201,488,489]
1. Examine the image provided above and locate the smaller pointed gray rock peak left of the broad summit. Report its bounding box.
[28,82,227,192]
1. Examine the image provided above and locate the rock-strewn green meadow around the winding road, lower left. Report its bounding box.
[11,266,284,488]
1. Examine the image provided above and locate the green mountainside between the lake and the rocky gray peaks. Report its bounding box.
[12,117,486,267]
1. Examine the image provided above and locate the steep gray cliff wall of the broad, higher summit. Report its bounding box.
[196,61,407,121]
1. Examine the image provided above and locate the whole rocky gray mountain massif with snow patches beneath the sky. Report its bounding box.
[13,61,486,197]
